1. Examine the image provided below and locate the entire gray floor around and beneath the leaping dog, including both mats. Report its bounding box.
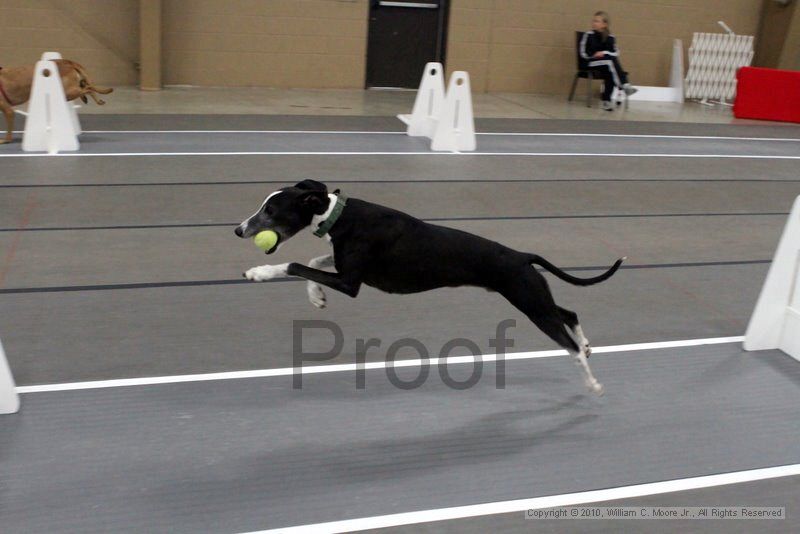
[0,115,800,532]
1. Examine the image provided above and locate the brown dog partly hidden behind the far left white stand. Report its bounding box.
[0,59,113,144]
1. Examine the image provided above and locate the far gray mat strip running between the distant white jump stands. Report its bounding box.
[0,116,800,158]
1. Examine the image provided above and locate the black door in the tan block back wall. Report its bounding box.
[366,0,449,89]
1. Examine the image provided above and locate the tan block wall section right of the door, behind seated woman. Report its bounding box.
[447,0,762,94]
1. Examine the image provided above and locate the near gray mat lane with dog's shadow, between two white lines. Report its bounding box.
[0,345,800,533]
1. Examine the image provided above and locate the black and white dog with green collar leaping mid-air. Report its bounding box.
[236,180,625,394]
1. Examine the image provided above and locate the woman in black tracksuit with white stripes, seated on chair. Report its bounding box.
[580,11,637,111]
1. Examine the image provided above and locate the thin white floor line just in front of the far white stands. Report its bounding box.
[0,151,800,160]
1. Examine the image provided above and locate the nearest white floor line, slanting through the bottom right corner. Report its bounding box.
[249,464,800,534]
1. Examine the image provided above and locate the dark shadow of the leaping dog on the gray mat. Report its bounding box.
[151,395,599,507]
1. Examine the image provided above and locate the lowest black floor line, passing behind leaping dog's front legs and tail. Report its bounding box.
[0,260,772,295]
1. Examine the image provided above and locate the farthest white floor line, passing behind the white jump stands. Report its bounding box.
[10,130,800,143]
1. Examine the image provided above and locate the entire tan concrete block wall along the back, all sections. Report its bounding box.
[0,0,764,94]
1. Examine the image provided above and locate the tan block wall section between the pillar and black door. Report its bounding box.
[163,0,368,88]
